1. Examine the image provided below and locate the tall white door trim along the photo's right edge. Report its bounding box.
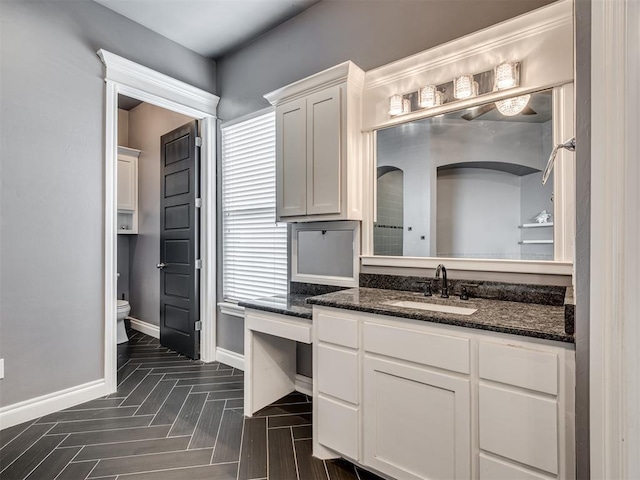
[592,0,640,479]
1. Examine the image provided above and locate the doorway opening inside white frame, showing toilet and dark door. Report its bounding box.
[116,95,200,359]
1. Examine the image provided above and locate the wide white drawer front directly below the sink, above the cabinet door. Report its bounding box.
[363,322,470,373]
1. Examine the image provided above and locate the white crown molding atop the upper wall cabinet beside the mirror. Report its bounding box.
[264,60,364,106]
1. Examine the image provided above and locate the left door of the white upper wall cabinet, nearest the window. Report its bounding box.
[276,98,307,218]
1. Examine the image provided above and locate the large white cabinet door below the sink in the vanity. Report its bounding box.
[364,355,471,480]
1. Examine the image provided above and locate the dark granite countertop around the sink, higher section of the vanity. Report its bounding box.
[307,287,574,343]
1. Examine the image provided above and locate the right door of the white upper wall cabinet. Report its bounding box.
[307,87,342,215]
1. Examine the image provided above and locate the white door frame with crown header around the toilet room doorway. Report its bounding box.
[97,49,220,393]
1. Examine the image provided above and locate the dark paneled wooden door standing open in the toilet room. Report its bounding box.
[158,121,200,359]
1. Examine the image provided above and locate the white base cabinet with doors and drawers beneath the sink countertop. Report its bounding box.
[313,306,575,480]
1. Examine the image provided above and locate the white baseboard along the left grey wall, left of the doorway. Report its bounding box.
[0,378,112,429]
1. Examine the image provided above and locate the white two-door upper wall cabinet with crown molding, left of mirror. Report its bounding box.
[265,62,364,222]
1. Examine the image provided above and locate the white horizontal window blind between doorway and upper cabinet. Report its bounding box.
[222,112,287,302]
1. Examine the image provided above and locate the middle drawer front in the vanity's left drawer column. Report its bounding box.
[317,345,359,404]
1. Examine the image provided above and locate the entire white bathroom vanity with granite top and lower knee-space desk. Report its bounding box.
[243,286,575,480]
